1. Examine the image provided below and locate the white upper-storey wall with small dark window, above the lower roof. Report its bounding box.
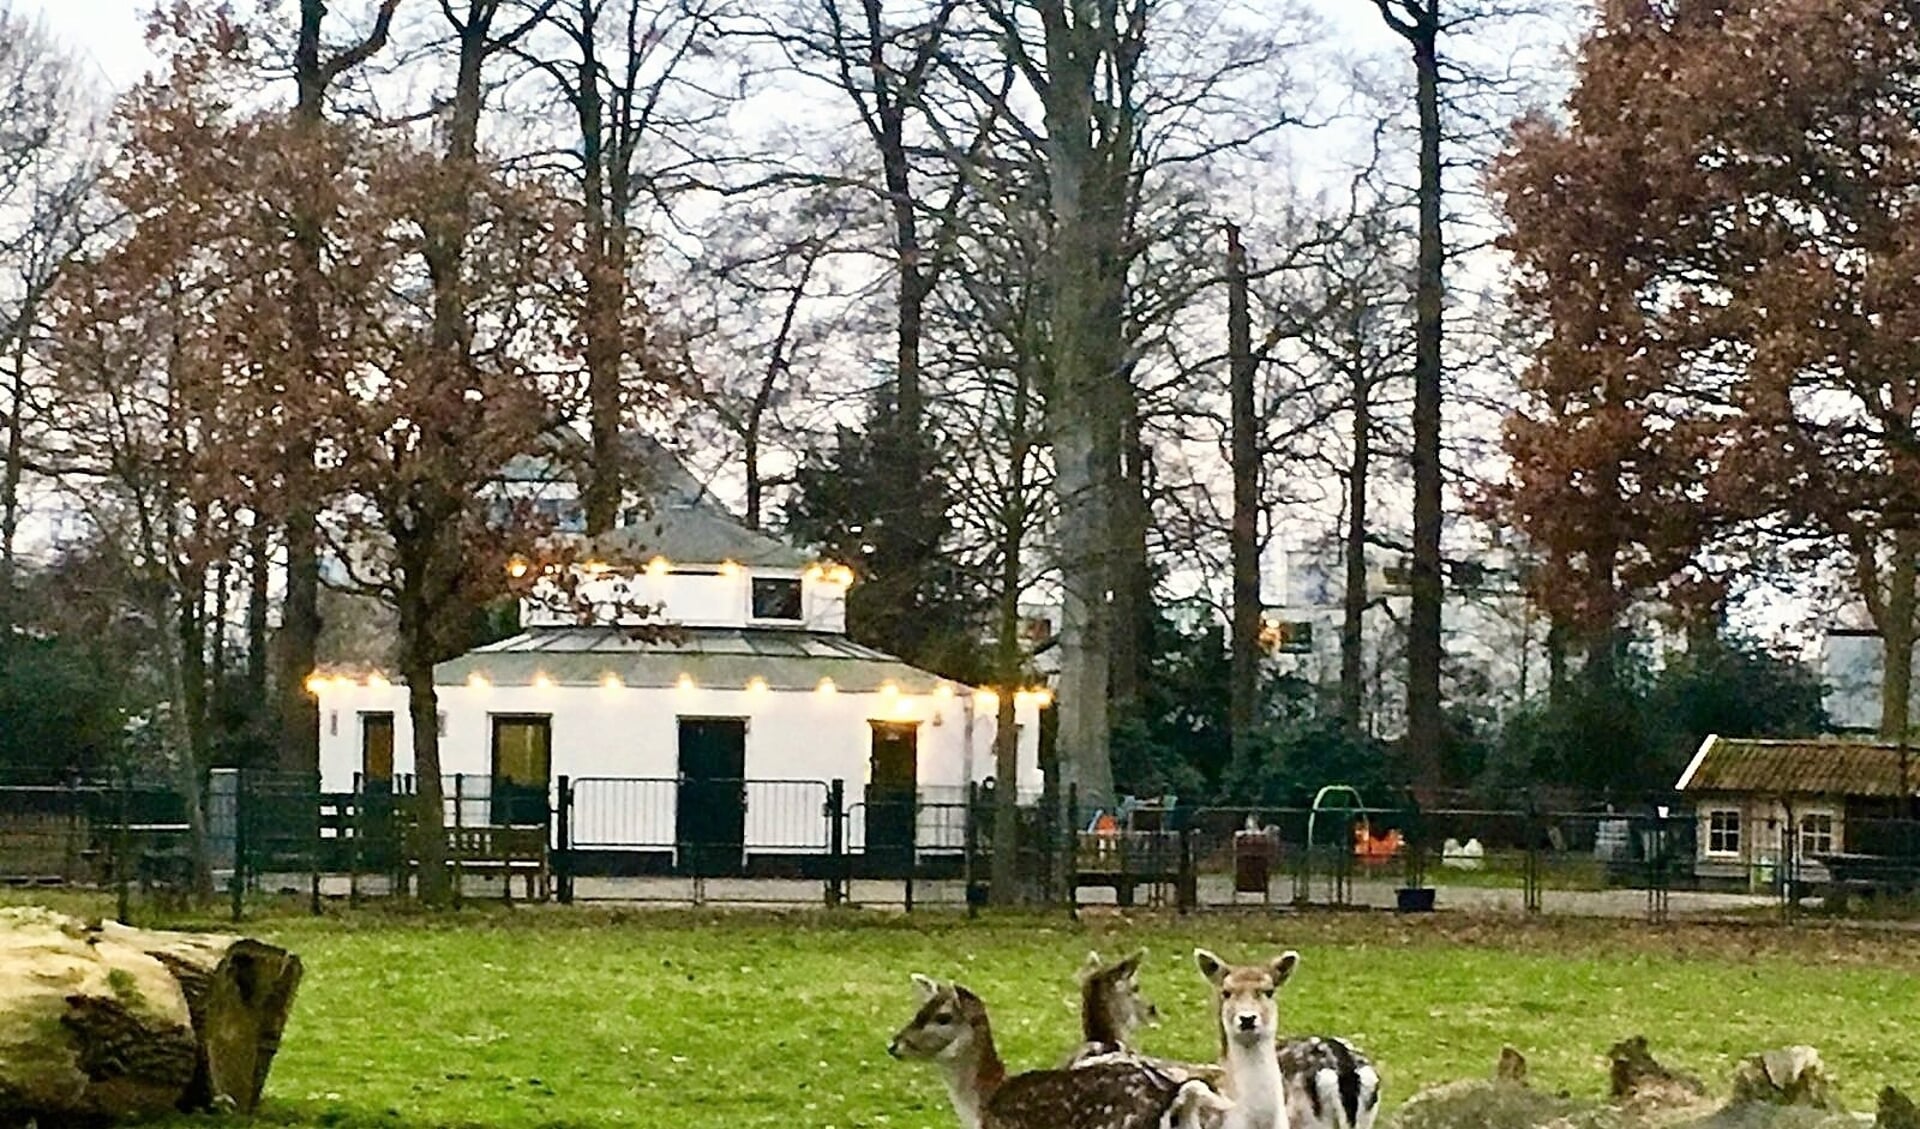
[520,568,847,634]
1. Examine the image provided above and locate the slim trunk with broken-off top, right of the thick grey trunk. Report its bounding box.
[1227,225,1261,770]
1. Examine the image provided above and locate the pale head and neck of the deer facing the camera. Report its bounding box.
[1194,949,1300,1129]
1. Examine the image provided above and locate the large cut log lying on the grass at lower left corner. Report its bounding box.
[0,908,301,1125]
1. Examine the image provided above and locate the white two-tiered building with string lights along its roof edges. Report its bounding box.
[313,441,1046,872]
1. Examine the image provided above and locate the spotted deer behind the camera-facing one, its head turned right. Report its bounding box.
[1069,954,1380,1129]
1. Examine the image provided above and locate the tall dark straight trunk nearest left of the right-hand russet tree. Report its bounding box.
[1405,8,1446,799]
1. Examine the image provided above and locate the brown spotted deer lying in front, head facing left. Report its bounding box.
[887,975,1231,1129]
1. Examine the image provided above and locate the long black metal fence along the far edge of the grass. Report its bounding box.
[0,770,1920,920]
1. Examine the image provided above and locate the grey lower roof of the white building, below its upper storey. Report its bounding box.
[434,628,947,693]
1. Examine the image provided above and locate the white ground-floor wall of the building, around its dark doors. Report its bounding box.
[319,680,1043,851]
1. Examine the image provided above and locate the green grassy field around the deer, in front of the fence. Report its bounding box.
[3,898,1920,1129]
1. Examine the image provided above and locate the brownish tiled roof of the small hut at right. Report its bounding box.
[1676,735,1920,797]
